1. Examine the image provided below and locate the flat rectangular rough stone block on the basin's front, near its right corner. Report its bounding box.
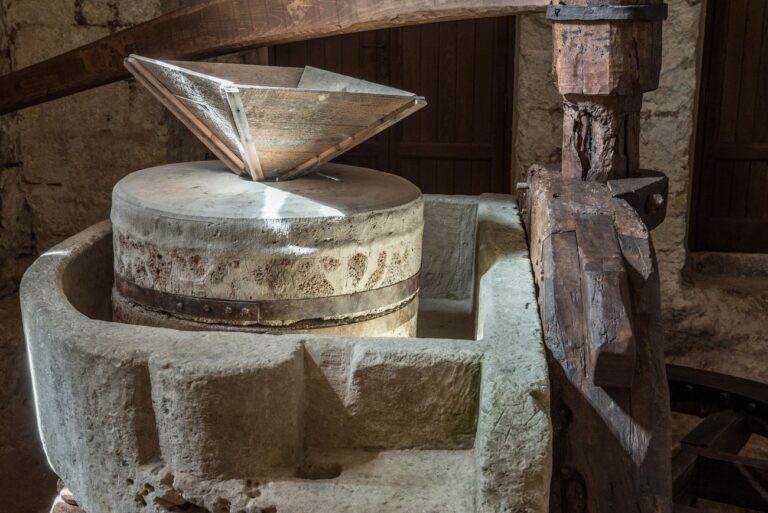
[344,341,481,449]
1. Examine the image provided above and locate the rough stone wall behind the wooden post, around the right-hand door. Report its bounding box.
[513,0,768,381]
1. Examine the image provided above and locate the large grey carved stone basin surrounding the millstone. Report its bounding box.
[21,195,552,513]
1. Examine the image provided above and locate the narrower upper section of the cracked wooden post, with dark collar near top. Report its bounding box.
[552,0,662,182]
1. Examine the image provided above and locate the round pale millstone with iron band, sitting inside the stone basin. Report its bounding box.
[111,161,423,336]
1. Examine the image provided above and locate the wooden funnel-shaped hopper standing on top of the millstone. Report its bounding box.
[125,55,426,180]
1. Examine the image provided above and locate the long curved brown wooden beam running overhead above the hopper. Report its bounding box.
[0,0,549,115]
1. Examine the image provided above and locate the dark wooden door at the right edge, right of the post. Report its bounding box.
[691,0,768,252]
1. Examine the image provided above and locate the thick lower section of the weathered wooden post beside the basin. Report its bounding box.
[523,166,672,513]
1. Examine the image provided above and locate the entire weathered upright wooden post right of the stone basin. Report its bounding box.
[519,0,672,513]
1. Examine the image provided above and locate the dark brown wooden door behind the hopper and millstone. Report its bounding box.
[272,18,514,194]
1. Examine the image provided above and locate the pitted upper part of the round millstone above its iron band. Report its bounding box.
[112,162,423,307]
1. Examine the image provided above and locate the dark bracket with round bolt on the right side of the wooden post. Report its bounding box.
[608,169,669,230]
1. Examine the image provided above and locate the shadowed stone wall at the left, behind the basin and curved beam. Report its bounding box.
[0,0,205,513]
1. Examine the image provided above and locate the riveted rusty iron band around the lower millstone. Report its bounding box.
[115,273,419,324]
